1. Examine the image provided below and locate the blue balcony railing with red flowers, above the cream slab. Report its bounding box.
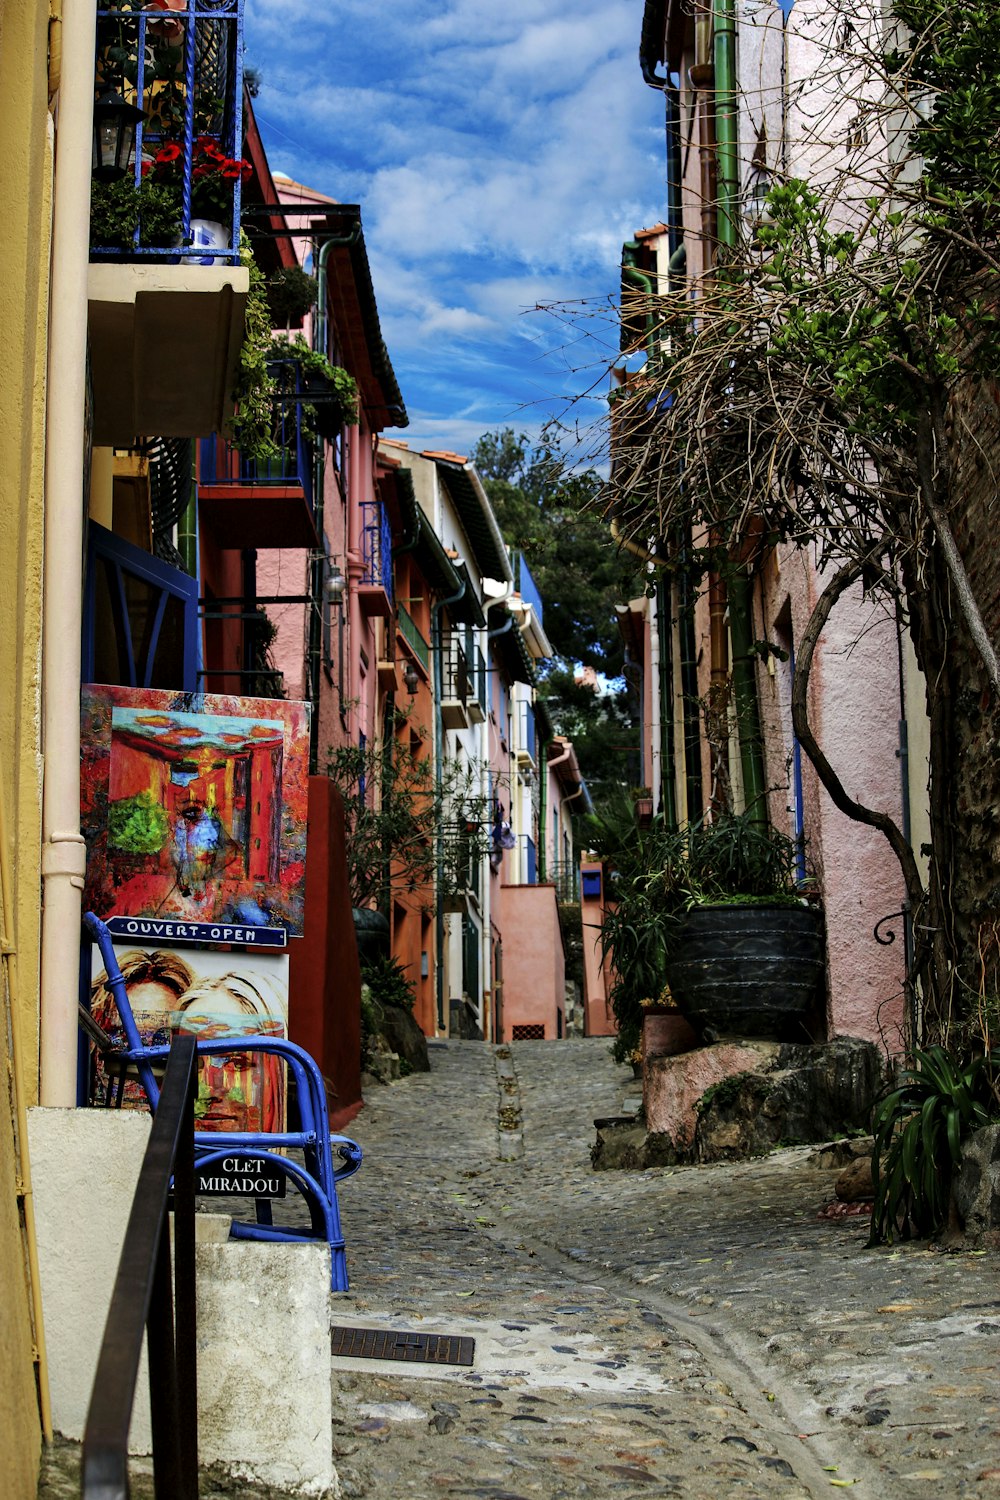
[91,0,250,266]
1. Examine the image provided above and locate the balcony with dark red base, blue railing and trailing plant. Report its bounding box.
[198,360,318,548]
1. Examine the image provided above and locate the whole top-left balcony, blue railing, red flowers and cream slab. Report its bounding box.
[88,0,249,447]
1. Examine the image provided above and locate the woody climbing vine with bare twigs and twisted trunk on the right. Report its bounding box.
[607,0,1000,1041]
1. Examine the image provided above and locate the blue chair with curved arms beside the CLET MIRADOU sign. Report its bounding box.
[84,912,361,1292]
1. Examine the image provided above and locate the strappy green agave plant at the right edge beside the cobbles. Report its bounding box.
[868,1047,1000,1245]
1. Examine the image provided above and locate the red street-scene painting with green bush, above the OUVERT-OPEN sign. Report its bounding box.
[81,686,309,938]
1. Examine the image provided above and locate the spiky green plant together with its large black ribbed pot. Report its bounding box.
[588,798,823,1061]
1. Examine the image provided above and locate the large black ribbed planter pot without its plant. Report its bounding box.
[667,903,825,1041]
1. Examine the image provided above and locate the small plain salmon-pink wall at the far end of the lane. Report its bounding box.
[498,885,565,1041]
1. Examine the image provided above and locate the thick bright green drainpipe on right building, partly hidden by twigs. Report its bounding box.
[715,0,768,825]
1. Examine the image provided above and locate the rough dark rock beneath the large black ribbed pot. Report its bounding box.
[695,1037,883,1161]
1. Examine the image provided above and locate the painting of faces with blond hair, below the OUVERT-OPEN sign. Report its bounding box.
[90,944,288,1131]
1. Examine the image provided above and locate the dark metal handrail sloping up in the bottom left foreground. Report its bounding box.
[81,1037,198,1500]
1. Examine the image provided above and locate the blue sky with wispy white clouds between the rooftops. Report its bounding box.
[246,0,666,453]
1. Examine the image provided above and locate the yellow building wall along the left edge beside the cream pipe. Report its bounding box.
[0,0,52,1482]
